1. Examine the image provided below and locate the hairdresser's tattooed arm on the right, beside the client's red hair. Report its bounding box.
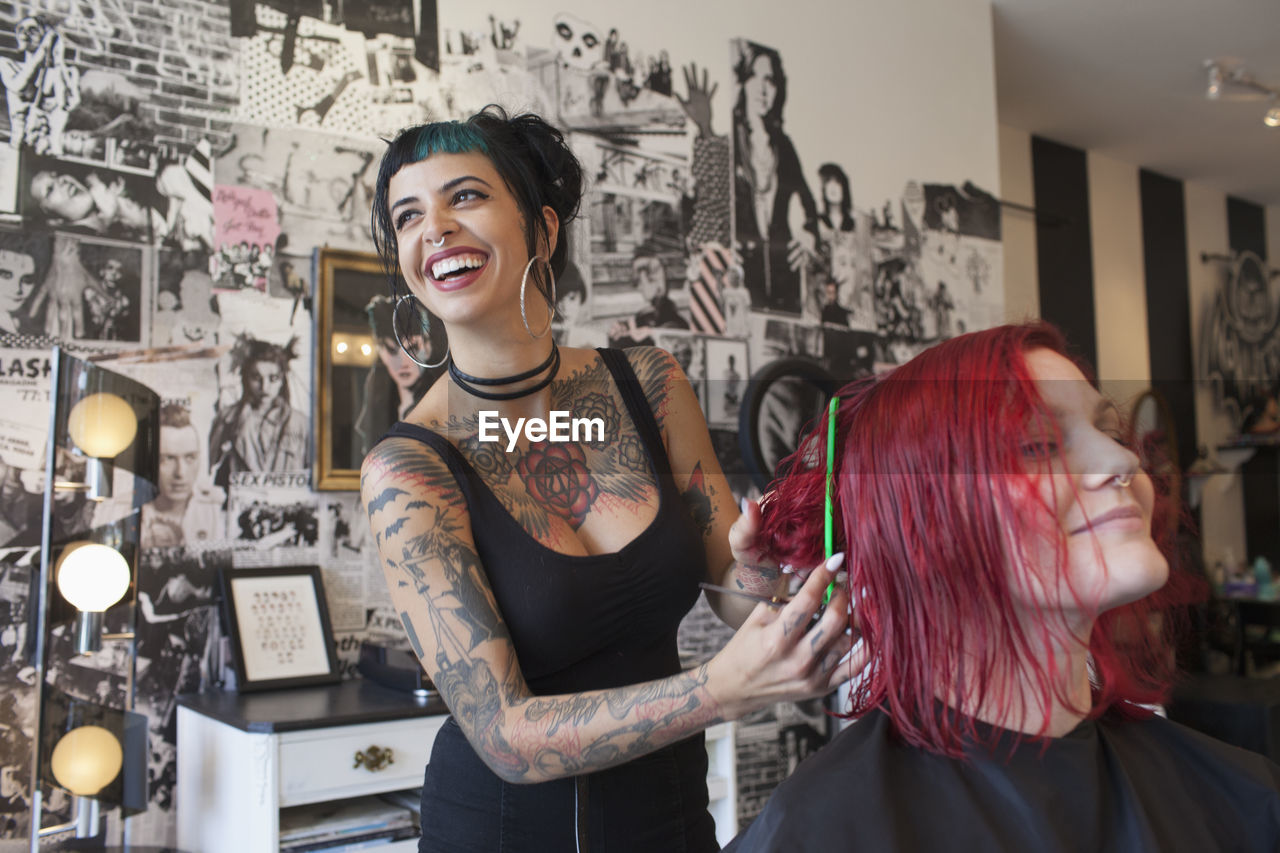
[627,347,782,628]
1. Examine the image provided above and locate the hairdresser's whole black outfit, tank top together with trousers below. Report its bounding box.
[378,350,718,853]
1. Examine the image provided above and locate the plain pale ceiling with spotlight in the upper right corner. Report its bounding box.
[992,0,1280,205]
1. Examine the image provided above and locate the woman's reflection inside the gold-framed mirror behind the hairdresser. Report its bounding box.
[356,296,443,459]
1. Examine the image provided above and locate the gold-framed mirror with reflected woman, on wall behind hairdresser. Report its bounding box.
[312,248,447,491]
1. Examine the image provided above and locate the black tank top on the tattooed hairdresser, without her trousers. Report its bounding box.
[378,350,707,693]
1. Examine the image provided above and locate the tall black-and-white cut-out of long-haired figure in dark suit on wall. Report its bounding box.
[733,41,818,314]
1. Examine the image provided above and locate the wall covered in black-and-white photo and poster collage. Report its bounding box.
[0,0,1002,844]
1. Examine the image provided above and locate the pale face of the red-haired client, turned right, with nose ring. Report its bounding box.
[1014,350,1169,617]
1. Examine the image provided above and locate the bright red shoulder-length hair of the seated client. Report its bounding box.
[760,323,1187,757]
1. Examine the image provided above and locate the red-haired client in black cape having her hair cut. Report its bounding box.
[731,324,1280,853]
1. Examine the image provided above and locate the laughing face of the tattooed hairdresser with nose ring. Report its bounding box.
[388,152,558,324]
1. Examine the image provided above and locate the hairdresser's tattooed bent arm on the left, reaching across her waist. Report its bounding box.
[361,438,850,783]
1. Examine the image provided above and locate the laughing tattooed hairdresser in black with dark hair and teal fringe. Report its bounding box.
[361,108,851,853]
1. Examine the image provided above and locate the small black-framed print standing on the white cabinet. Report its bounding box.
[221,566,340,693]
